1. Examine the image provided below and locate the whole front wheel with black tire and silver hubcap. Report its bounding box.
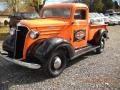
[45,50,67,77]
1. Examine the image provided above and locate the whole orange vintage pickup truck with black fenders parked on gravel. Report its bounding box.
[0,3,108,77]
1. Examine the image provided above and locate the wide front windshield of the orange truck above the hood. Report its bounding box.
[42,7,70,18]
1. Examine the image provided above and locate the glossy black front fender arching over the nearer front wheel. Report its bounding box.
[28,37,75,63]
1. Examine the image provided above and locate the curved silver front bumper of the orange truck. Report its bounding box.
[0,52,41,69]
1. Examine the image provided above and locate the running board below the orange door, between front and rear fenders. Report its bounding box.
[71,45,100,60]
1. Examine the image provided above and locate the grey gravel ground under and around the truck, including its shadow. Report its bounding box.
[0,26,120,90]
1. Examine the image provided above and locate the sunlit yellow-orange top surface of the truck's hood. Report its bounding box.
[20,19,67,28]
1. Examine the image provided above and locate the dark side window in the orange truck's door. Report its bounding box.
[74,10,86,20]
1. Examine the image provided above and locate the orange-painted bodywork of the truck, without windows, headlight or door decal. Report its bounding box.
[17,3,106,60]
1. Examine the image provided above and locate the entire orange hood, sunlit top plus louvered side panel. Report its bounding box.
[18,19,69,39]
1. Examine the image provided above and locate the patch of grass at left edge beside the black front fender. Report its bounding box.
[0,26,9,40]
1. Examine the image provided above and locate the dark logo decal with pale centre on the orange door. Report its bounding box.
[74,30,86,41]
